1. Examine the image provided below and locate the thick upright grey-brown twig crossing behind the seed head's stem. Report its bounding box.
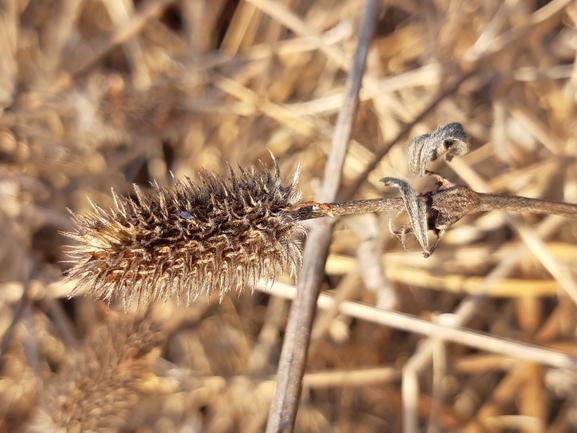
[266,0,378,433]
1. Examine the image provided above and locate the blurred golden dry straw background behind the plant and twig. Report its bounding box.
[0,0,577,433]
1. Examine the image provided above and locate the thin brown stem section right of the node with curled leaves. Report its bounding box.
[477,193,577,218]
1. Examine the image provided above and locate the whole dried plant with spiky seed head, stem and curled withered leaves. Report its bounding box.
[65,123,577,306]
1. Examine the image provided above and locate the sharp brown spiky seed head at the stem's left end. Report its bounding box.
[64,161,303,307]
